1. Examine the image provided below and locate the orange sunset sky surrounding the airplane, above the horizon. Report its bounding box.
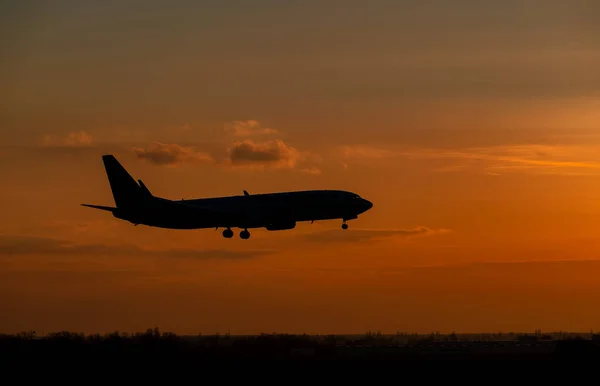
[0,0,600,334]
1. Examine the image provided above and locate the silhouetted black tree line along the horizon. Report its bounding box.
[0,328,600,361]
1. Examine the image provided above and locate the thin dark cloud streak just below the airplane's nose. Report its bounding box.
[302,226,449,243]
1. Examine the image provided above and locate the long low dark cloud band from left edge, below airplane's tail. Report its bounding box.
[0,235,275,259]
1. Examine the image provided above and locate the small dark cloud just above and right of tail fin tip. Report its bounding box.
[133,142,213,166]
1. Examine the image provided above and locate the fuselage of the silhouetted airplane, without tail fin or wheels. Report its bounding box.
[114,190,371,230]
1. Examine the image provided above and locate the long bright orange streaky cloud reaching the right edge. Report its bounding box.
[341,144,600,176]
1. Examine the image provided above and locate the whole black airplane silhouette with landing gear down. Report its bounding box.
[81,154,373,239]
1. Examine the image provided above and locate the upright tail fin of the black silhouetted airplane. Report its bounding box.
[102,154,149,208]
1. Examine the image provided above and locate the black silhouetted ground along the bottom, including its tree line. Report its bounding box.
[0,330,600,386]
